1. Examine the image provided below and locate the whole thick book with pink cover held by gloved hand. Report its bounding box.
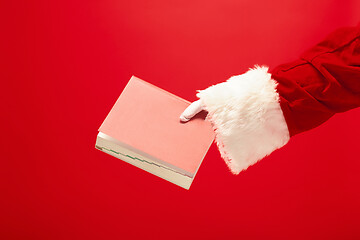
[95,76,214,189]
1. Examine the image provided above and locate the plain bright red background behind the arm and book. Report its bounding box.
[0,0,360,239]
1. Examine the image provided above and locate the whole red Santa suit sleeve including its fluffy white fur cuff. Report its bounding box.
[197,24,360,174]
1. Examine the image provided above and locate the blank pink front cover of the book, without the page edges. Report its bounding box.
[99,76,214,173]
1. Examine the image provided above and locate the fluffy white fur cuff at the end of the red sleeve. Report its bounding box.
[197,66,290,174]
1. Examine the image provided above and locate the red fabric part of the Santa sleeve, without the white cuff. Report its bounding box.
[272,24,360,136]
